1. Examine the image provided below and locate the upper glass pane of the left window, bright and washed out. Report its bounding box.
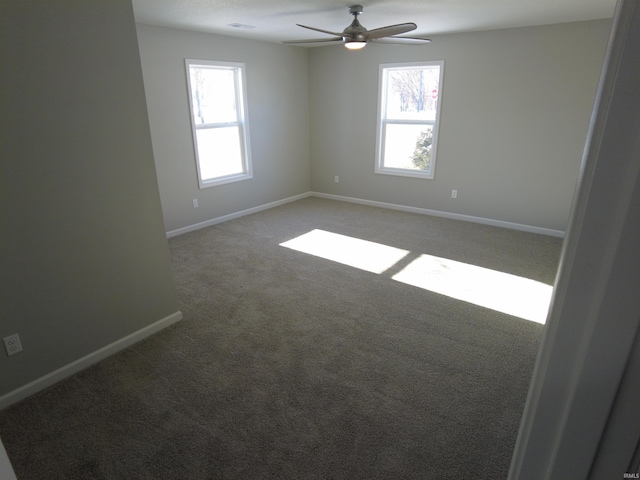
[189,66,238,125]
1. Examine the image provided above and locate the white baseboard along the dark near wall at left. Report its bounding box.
[0,311,182,410]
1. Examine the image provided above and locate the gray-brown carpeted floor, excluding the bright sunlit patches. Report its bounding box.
[0,198,561,480]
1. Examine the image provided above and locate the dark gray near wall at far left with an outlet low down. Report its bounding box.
[0,0,178,395]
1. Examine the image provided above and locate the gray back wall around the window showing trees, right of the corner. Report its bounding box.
[309,20,610,230]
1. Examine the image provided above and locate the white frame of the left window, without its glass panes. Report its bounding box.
[185,58,253,189]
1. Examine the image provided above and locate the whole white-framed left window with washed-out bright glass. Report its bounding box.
[186,59,253,188]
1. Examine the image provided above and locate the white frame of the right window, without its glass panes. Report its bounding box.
[374,60,444,179]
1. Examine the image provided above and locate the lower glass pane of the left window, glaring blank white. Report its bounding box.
[196,126,244,181]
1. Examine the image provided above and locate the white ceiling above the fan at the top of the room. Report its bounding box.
[133,0,616,42]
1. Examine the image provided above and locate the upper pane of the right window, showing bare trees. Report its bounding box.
[386,66,440,121]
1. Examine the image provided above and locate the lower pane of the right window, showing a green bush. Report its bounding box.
[383,124,433,171]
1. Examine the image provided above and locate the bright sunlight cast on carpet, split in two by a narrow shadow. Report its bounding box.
[280,229,553,324]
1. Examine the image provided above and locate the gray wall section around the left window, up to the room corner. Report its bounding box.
[137,25,310,231]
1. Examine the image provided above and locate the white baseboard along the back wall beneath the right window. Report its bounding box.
[310,192,564,238]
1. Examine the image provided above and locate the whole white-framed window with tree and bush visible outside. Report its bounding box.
[375,61,444,178]
